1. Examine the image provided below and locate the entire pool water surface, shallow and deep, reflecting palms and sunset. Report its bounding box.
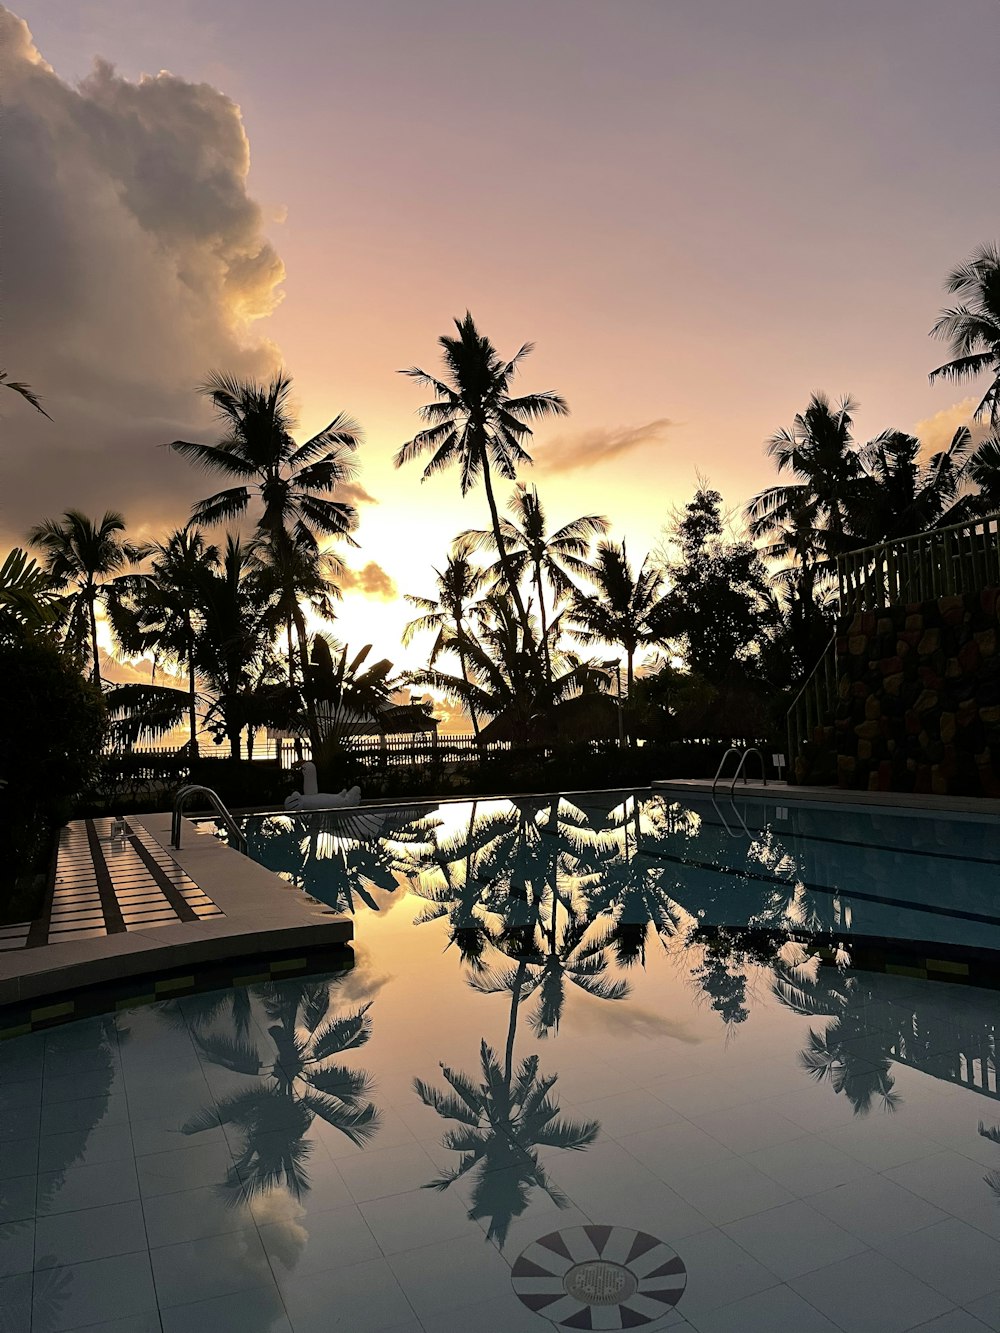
[0,792,1000,1333]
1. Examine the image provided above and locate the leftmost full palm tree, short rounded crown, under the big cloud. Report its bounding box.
[28,509,144,686]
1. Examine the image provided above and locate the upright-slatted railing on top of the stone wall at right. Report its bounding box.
[837,515,1000,616]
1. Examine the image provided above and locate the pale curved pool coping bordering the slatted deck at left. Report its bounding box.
[0,813,355,1008]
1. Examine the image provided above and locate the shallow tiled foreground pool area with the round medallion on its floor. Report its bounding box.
[0,890,1000,1333]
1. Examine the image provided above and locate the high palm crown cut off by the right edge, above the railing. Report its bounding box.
[928,244,1000,427]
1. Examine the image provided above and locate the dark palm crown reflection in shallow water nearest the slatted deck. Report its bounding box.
[181,978,379,1198]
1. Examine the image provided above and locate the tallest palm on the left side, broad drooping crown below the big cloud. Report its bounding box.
[171,371,361,746]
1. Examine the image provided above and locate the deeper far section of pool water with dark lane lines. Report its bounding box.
[237,790,1000,952]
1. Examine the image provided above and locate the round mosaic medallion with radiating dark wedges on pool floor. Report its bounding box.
[511,1226,688,1329]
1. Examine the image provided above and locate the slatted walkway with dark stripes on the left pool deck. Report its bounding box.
[0,818,224,953]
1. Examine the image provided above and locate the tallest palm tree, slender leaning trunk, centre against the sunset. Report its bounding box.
[393,311,569,666]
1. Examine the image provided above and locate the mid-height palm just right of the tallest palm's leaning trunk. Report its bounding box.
[456,483,611,682]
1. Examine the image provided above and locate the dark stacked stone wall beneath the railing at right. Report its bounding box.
[832,588,1000,796]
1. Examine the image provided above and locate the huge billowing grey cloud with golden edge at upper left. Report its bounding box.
[0,5,284,540]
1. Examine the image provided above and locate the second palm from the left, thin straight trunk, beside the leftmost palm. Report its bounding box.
[108,525,219,756]
